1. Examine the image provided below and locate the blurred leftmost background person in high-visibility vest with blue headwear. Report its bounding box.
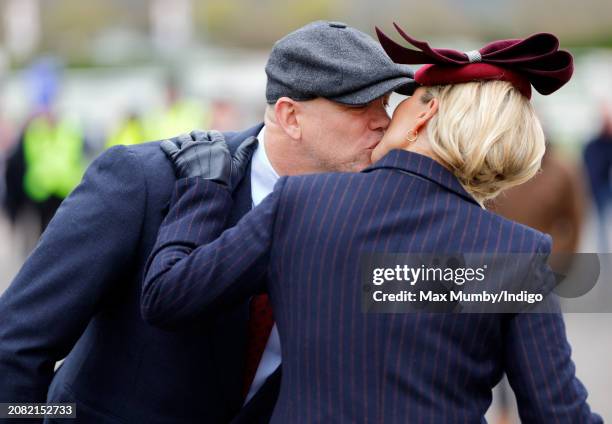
[6,59,85,240]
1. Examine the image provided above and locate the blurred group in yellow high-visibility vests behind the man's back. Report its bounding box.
[0,60,249,252]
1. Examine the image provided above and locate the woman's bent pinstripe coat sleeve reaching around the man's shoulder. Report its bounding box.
[141,178,285,328]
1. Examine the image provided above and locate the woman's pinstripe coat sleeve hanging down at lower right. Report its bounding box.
[504,236,603,424]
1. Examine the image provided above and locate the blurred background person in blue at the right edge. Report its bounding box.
[584,105,612,253]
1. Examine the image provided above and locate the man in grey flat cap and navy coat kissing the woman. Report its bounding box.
[0,22,412,423]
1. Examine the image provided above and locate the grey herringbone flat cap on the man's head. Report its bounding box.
[266,21,415,105]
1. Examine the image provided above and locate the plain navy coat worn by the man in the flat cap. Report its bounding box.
[0,125,280,424]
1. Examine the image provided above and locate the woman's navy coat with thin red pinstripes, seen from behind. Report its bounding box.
[142,151,601,423]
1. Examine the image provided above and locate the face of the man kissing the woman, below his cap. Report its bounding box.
[300,95,390,172]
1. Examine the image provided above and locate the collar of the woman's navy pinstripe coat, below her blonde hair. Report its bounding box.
[363,150,480,206]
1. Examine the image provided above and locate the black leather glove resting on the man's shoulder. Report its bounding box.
[160,130,257,190]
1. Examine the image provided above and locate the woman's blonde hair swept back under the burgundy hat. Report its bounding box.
[421,81,545,205]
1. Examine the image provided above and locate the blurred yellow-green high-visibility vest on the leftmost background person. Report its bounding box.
[23,117,85,202]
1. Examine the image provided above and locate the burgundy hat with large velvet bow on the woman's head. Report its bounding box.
[376,23,574,99]
